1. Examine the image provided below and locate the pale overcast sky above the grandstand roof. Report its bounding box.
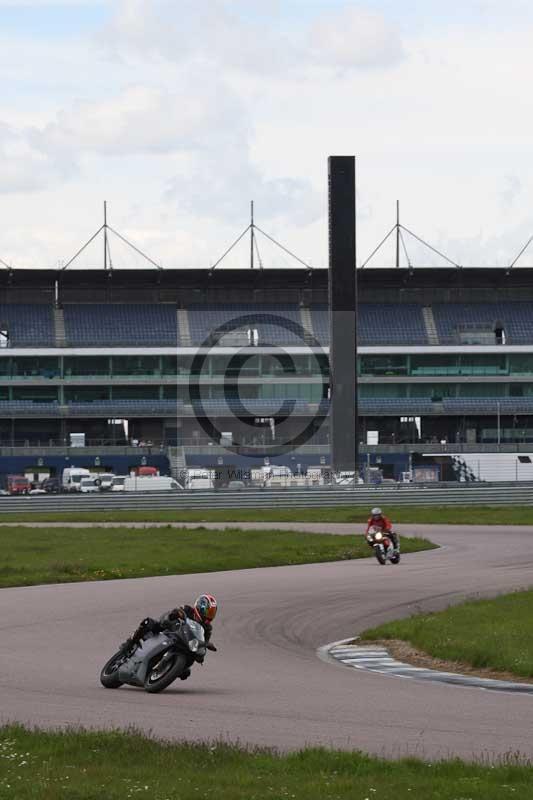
[0,0,533,267]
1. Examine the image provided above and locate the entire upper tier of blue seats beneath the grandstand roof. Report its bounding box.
[4,301,533,347]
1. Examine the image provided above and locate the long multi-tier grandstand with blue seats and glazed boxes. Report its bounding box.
[0,268,533,482]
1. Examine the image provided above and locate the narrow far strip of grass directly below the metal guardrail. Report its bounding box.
[0,506,533,525]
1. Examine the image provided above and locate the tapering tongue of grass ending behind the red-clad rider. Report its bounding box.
[0,526,435,587]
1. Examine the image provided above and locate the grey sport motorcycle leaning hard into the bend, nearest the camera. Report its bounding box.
[100,618,209,694]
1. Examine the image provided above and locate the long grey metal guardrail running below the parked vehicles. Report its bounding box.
[0,483,533,515]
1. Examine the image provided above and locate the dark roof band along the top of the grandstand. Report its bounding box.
[0,267,533,304]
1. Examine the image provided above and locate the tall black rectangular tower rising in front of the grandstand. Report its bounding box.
[328,156,358,471]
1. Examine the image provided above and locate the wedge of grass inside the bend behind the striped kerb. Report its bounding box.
[361,591,533,680]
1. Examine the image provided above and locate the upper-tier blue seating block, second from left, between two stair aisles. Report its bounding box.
[63,303,178,347]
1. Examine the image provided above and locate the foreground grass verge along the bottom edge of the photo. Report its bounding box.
[0,726,533,800]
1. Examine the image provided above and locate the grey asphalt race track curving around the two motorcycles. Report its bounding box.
[0,523,533,760]
